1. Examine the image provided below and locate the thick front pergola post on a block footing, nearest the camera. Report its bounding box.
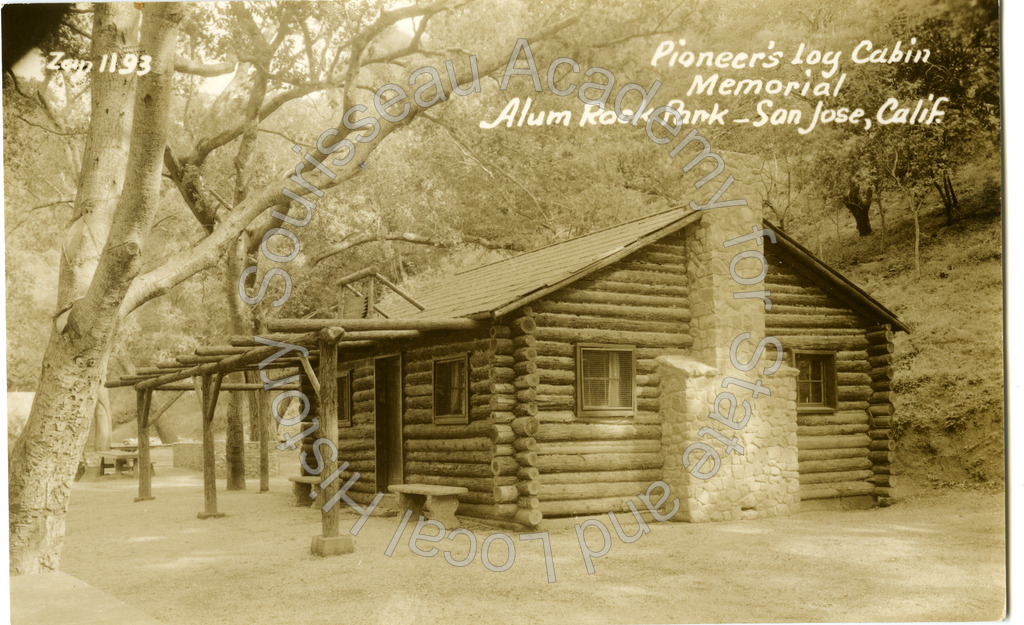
[309,328,355,555]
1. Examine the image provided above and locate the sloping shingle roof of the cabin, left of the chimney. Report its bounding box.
[389,207,700,318]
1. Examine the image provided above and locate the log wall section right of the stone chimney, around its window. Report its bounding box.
[765,248,876,501]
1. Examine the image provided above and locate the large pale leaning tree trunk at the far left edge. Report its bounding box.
[8,3,181,575]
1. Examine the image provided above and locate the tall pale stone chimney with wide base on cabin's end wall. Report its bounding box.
[657,148,800,522]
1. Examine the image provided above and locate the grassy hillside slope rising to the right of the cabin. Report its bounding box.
[794,183,1005,488]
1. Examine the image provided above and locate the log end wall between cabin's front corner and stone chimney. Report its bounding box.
[520,228,692,517]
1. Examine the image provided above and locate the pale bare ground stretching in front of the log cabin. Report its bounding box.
[51,450,1006,625]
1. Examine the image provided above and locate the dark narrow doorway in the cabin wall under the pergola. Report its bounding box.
[374,356,403,493]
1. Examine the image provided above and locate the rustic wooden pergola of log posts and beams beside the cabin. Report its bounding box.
[106,311,482,538]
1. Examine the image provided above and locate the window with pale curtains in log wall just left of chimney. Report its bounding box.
[577,345,636,417]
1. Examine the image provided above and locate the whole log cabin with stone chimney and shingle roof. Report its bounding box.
[109,151,907,536]
